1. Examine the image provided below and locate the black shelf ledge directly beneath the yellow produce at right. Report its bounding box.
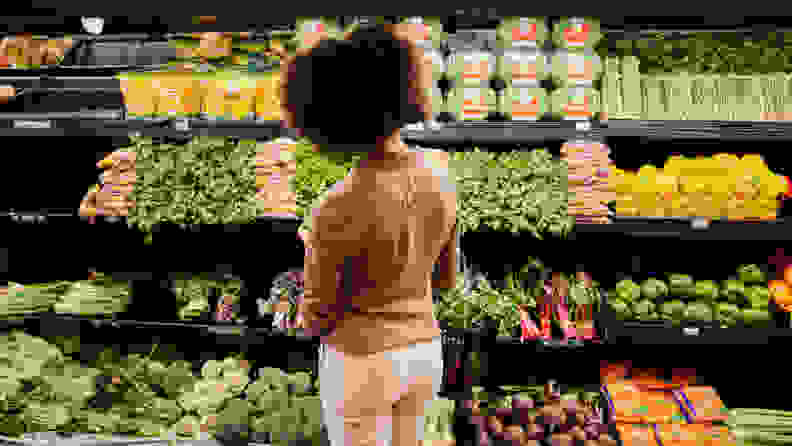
[569,218,792,241]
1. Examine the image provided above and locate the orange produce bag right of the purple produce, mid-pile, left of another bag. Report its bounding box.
[605,381,685,424]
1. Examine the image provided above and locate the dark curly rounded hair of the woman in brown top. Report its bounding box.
[281,25,429,151]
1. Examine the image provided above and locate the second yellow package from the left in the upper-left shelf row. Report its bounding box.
[152,71,202,117]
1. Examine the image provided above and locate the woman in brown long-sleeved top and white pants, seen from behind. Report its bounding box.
[281,25,456,446]
